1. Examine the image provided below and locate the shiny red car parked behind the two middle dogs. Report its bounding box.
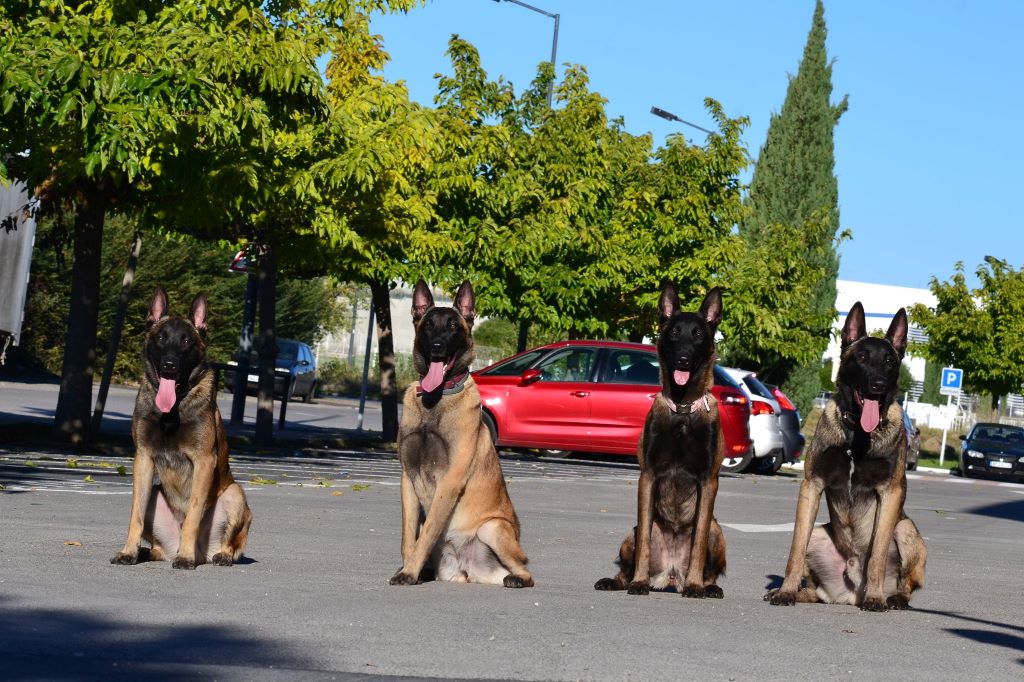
[473,341,752,471]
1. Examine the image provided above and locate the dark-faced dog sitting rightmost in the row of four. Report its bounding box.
[765,301,928,611]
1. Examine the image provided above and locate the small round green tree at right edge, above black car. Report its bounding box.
[910,258,1024,408]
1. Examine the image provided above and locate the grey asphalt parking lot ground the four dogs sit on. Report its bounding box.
[0,446,1024,680]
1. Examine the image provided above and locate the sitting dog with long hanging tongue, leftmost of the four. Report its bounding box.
[111,288,252,568]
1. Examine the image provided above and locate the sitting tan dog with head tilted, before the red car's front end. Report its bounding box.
[391,280,534,588]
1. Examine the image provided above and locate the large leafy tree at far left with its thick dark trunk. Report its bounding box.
[0,0,413,442]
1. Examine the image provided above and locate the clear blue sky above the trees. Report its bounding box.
[373,0,1024,289]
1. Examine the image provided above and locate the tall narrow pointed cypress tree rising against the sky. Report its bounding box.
[740,0,847,412]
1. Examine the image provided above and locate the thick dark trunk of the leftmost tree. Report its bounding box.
[53,186,108,445]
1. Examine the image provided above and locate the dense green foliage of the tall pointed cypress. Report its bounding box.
[734,0,847,412]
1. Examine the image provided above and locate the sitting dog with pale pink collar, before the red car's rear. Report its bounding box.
[594,285,725,598]
